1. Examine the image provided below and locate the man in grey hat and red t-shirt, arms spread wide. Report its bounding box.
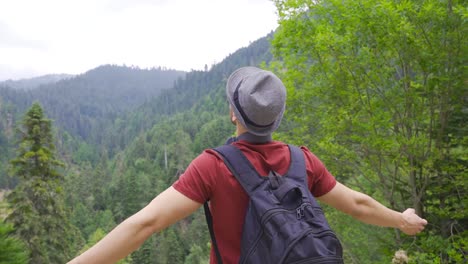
[70,67,427,264]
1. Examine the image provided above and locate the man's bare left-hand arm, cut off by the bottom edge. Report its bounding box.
[69,187,201,264]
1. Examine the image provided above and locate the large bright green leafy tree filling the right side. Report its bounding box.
[273,0,468,262]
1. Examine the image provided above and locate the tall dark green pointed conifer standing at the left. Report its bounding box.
[6,103,74,263]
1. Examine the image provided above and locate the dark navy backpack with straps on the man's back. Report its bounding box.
[205,145,343,264]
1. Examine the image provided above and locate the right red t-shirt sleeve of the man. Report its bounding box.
[301,147,336,197]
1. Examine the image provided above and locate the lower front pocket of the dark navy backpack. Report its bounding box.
[239,206,342,264]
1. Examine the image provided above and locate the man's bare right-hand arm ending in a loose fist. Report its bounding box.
[317,182,427,235]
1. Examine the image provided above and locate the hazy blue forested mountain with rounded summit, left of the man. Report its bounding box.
[0,65,186,141]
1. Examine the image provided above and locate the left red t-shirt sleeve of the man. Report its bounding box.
[172,151,219,203]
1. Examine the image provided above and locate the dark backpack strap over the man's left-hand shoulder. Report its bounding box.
[214,145,264,196]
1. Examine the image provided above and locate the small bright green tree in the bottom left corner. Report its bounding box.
[0,221,29,264]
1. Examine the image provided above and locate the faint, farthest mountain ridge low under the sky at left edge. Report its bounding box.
[0,73,74,90]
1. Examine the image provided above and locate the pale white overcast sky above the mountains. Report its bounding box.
[0,0,278,81]
